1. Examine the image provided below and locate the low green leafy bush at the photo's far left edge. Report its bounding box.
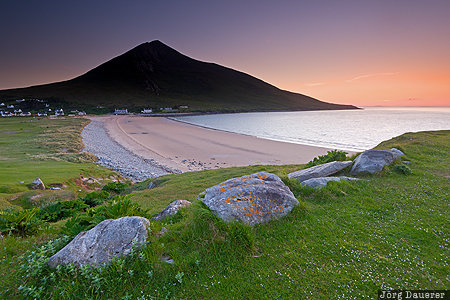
[0,208,43,237]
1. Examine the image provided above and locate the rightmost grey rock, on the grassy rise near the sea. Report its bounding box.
[350,150,397,175]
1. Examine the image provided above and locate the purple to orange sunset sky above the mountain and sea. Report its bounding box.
[0,0,450,106]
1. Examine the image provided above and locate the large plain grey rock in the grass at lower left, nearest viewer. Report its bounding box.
[47,217,150,268]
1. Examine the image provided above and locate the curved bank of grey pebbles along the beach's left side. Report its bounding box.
[81,121,180,182]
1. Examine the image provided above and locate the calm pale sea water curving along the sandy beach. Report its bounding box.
[175,107,450,151]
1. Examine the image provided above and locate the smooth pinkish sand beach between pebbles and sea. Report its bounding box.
[89,116,330,172]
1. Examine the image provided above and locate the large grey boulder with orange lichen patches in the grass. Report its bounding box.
[199,172,298,225]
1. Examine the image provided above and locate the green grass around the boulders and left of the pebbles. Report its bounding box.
[0,119,450,299]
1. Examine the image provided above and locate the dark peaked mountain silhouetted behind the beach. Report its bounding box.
[0,41,356,112]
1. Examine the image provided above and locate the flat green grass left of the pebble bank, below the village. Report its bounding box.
[0,118,118,209]
